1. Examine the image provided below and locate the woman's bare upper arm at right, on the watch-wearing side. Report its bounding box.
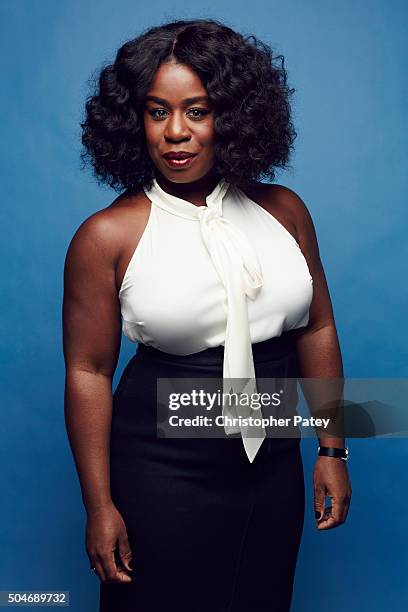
[266,185,334,329]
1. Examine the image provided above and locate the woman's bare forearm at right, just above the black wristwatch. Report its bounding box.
[297,324,345,448]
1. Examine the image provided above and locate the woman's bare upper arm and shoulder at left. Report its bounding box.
[62,211,121,376]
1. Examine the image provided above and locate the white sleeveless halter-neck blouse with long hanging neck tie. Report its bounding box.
[119,178,313,461]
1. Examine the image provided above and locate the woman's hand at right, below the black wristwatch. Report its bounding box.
[313,456,352,530]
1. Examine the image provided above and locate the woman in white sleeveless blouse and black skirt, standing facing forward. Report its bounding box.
[63,20,351,612]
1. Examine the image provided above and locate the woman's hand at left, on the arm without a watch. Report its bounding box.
[86,503,132,582]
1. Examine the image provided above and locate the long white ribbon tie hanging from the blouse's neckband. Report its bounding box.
[146,179,266,463]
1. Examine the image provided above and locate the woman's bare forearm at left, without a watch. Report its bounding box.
[65,368,112,513]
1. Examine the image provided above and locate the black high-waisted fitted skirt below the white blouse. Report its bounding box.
[99,332,305,612]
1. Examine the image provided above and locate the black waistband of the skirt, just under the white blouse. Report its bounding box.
[136,329,298,365]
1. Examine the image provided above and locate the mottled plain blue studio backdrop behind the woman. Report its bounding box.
[0,0,408,612]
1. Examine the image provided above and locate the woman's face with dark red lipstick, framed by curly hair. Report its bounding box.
[144,63,215,183]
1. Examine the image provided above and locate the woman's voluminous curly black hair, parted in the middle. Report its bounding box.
[81,19,296,191]
